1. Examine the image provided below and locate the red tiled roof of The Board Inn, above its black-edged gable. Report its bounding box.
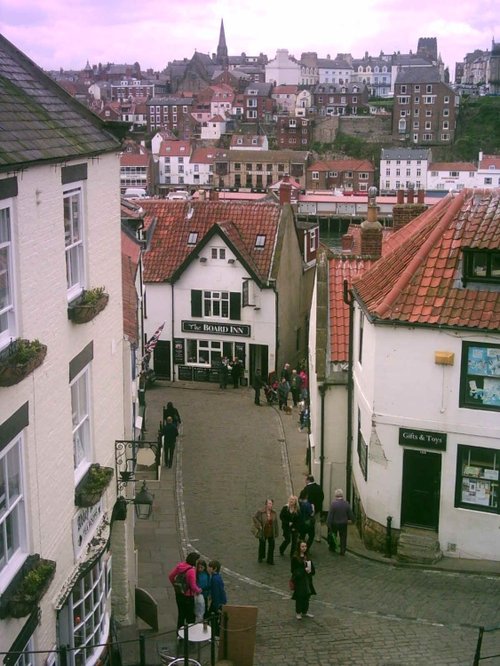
[141,199,281,282]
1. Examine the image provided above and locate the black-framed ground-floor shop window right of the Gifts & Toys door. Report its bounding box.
[455,444,500,513]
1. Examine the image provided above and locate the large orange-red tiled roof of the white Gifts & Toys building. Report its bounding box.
[353,188,500,331]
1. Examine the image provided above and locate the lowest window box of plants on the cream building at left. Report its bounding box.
[8,555,56,618]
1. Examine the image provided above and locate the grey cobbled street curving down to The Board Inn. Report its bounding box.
[117,381,500,666]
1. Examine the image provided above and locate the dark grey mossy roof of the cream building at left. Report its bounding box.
[0,35,120,171]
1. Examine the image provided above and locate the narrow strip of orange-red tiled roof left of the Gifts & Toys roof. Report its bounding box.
[328,255,374,363]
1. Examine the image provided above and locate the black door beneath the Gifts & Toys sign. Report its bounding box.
[401,449,441,530]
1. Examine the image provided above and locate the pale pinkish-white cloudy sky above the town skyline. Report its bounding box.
[0,0,500,79]
